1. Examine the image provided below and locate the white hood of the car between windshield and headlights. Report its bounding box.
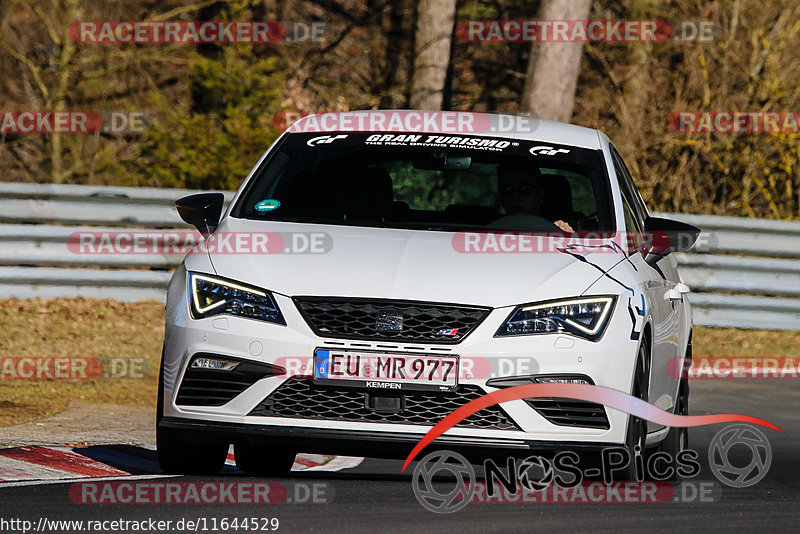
[209,217,623,308]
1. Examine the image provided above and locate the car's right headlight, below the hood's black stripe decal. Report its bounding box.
[495,297,616,341]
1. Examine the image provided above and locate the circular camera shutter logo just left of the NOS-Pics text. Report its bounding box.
[412,451,475,514]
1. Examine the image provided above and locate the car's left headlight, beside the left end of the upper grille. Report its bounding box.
[189,273,286,325]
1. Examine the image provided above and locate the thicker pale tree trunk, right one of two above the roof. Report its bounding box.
[521,0,592,122]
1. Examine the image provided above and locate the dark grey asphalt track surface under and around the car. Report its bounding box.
[0,379,800,534]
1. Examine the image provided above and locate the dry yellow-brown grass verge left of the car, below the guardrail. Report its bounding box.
[0,298,164,426]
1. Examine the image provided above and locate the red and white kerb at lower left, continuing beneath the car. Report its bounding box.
[0,445,364,487]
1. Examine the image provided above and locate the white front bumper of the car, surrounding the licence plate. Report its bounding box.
[162,270,638,456]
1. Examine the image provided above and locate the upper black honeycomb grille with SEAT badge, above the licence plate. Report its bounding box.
[294,297,491,343]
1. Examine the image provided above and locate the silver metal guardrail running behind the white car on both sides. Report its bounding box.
[0,183,800,330]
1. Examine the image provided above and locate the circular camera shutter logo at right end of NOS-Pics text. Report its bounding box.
[708,425,772,488]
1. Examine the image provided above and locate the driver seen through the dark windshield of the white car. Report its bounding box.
[497,164,574,232]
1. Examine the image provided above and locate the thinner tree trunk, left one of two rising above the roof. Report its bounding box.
[411,0,456,109]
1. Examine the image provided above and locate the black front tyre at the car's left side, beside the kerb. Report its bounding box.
[156,350,228,475]
